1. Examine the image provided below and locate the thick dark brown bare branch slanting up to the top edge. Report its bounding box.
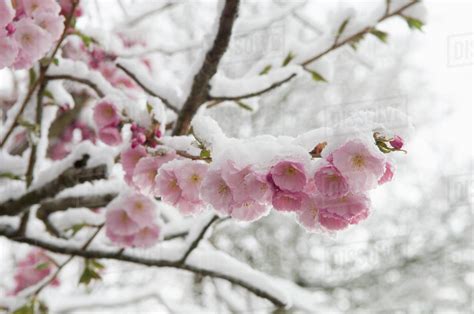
[173,0,239,135]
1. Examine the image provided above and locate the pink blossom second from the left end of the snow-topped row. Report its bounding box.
[133,151,176,194]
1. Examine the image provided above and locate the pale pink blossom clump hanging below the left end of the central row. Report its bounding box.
[105,193,160,247]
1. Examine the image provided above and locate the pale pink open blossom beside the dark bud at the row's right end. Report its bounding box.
[332,140,385,192]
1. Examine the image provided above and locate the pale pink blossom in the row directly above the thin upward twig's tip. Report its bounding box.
[201,170,235,215]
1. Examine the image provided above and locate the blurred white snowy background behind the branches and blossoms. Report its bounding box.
[0,0,474,313]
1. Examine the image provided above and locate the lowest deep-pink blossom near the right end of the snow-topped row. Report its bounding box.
[319,194,370,230]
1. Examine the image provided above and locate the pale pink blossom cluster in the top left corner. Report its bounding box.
[0,0,64,69]
